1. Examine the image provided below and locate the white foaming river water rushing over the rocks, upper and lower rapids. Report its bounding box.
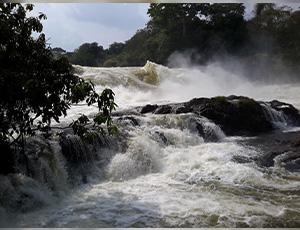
[0,62,300,227]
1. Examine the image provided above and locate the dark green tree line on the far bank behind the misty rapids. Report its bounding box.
[63,3,300,80]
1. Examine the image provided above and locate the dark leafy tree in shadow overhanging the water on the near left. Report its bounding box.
[0,3,116,173]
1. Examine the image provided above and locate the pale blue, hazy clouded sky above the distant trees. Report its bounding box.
[30,3,149,52]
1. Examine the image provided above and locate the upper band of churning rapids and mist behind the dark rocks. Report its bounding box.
[78,57,300,111]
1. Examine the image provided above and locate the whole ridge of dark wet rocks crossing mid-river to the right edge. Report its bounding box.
[138,96,300,135]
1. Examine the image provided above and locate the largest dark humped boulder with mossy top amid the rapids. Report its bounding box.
[187,96,272,135]
